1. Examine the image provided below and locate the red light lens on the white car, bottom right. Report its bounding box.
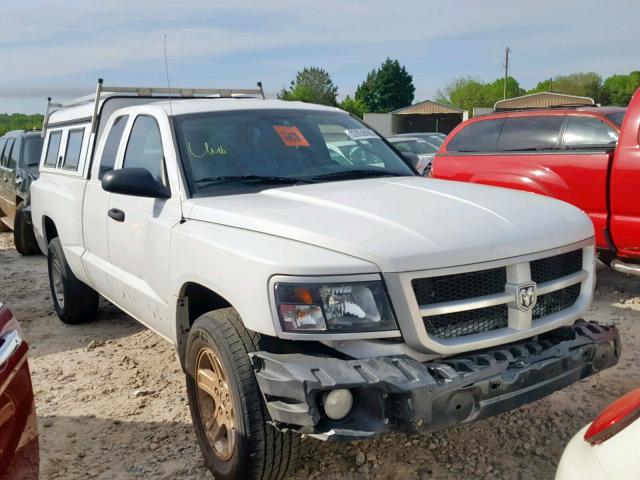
[584,388,640,445]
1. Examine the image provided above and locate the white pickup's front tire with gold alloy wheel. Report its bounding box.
[185,308,300,480]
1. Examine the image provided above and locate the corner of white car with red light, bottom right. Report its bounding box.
[556,388,640,480]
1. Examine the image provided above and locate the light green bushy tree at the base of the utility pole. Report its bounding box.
[436,77,525,111]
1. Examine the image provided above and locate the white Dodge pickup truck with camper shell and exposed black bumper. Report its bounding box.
[31,82,620,479]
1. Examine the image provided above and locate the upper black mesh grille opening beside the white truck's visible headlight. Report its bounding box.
[411,267,507,305]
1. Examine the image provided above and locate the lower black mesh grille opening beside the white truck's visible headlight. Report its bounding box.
[424,305,509,339]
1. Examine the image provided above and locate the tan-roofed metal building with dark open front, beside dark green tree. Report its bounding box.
[364,100,469,137]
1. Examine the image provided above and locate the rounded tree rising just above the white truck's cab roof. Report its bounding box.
[278,67,338,106]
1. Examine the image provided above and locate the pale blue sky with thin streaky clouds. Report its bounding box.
[0,0,640,113]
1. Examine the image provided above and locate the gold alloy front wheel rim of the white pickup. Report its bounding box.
[196,348,236,461]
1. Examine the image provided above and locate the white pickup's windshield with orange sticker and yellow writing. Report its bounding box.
[175,109,415,196]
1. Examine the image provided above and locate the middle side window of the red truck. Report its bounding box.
[498,115,564,152]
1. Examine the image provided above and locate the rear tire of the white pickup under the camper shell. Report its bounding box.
[47,237,100,325]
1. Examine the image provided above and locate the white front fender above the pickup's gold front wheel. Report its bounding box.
[171,220,380,336]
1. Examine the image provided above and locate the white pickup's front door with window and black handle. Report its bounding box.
[105,114,181,337]
